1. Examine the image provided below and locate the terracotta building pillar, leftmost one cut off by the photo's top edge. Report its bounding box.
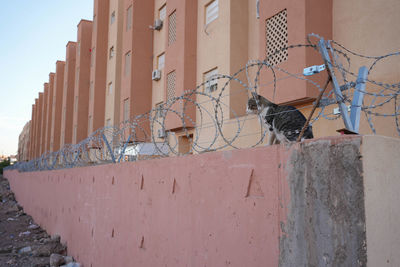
[87,0,110,136]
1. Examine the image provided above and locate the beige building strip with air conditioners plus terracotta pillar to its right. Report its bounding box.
[151,0,198,153]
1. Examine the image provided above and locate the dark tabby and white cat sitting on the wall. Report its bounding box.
[247,94,314,145]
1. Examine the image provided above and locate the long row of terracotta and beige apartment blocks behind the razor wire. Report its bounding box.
[19,0,400,159]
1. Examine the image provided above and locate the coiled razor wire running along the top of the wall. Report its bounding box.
[9,34,400,171]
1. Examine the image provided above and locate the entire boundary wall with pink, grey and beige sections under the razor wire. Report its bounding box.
[6,136,400,267]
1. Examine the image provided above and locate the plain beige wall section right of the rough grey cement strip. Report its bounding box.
[362,136,400,267]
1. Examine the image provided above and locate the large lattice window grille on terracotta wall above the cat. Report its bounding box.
[266,9,288,65]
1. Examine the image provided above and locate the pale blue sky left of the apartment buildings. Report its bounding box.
[0,0,93,155]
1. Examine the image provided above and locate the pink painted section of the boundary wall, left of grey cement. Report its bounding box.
[6,146,289,267]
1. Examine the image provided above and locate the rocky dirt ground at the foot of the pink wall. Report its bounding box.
[0,175,67,267]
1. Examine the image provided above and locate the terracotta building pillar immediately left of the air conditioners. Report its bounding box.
[120,0,154,129]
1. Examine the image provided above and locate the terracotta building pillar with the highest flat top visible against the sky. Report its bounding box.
[72,20,93,144]
